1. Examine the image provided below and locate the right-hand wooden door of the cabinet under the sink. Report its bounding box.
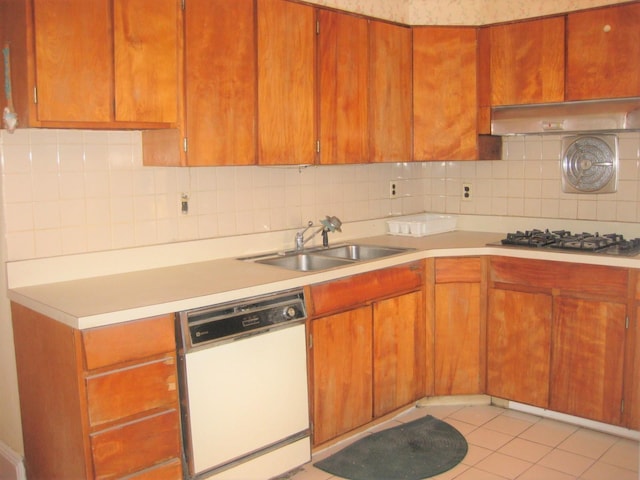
[373,292,426,417]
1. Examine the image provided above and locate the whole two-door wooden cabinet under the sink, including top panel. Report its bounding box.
[308,262,426,446]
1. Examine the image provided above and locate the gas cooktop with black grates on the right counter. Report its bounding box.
[490,229,640,256]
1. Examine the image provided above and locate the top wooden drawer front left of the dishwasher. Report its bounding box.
[82,315,176,370]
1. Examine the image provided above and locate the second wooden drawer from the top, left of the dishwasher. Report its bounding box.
[87,356,178,426]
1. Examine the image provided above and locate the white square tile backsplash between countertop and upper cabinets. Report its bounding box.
[0,129,640,260]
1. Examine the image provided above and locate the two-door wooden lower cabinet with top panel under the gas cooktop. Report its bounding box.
[487,257,635,425]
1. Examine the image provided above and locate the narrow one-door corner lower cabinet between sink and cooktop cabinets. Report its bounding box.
[431,257,486,395]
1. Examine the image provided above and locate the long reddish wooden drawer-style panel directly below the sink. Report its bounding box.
[310,261,425,316]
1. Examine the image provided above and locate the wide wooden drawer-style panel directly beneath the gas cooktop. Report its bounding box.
[489,257,629,298]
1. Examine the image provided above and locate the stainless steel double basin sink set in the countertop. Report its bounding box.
[241,244,412,272]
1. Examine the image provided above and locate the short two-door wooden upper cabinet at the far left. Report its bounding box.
[27,0,182,128]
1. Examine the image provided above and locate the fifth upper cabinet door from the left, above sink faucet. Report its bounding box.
[318,10,369,164]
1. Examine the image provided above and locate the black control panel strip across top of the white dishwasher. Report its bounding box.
[178,288,307,349]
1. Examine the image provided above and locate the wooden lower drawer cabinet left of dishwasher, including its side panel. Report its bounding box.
[12,303,182,480]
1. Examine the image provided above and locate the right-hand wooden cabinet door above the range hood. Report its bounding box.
[567,2,640,100]
